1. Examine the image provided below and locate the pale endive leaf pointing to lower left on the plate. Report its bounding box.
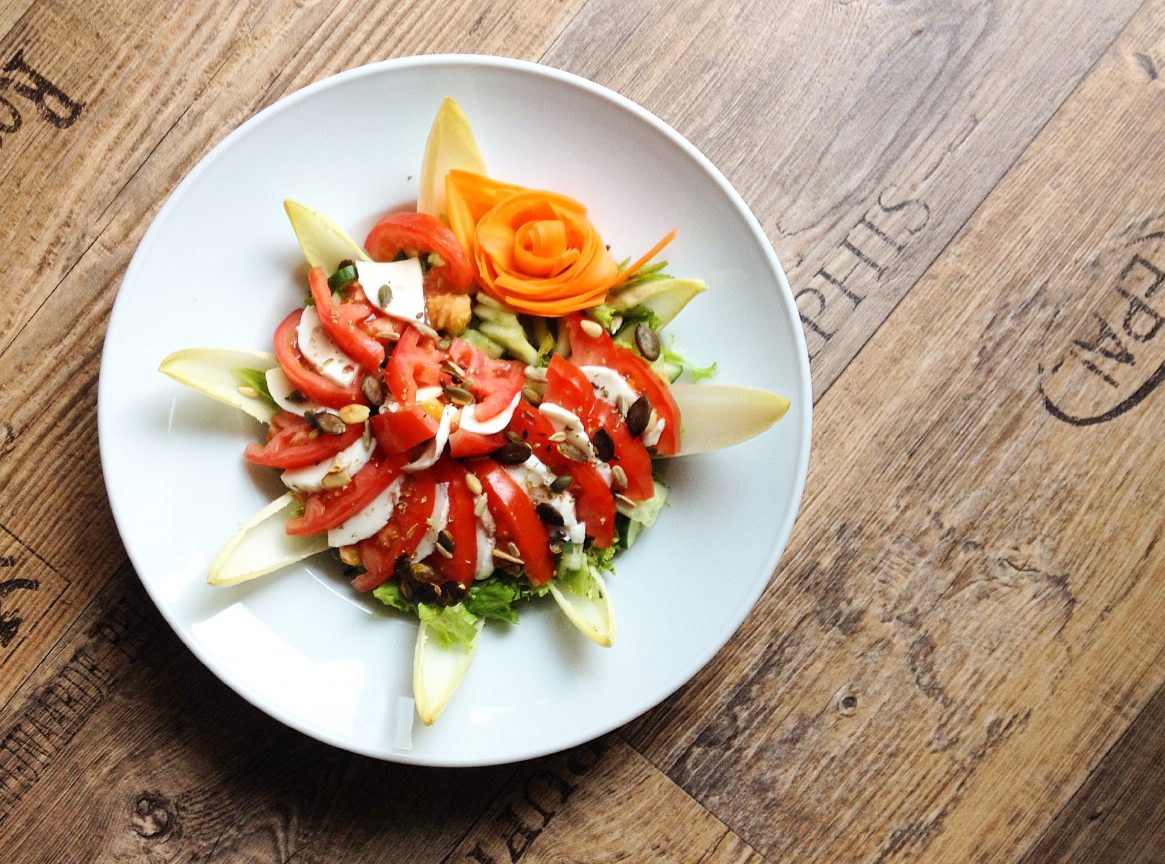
[206,493,327,586]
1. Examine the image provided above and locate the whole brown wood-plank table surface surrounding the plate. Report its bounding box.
[0,0,1165,864]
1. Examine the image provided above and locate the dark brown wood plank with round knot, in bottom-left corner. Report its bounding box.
[0,567,513,864]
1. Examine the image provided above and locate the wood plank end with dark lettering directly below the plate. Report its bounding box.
[445,736,763,864]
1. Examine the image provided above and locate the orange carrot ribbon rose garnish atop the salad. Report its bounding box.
[445,170,675,316]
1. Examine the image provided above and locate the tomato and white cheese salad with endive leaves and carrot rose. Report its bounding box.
[161,99,789,723]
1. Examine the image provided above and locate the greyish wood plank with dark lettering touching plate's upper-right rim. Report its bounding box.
[546,0,1141,394]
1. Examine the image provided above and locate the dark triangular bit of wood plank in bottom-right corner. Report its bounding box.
[1022,689,1165,864]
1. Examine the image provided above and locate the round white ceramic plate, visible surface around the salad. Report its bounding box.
[98,56,811,765]
